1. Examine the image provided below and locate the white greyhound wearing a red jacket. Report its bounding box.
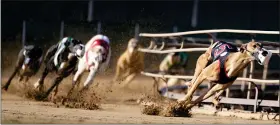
[67,34,111,96]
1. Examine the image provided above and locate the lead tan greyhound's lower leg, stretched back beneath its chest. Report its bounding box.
[187,82,233,108]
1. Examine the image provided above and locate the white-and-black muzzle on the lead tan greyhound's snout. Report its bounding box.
[253,48,272,65]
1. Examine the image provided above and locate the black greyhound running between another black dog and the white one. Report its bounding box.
[34,37,84,100]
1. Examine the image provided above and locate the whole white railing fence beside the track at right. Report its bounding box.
[138,29,280,112]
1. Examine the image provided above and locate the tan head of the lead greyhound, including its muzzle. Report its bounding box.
[240,40,272,65]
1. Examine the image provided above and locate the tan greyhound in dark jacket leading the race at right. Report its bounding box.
[178,40,272,108]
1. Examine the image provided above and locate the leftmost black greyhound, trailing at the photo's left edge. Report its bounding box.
[2,45,43,91]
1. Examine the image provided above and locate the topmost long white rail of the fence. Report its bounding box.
[139,29,280,37]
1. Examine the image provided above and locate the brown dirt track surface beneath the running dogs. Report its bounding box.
[1,76,278,124]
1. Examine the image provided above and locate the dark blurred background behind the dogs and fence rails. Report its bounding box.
[1,0,280,79]
